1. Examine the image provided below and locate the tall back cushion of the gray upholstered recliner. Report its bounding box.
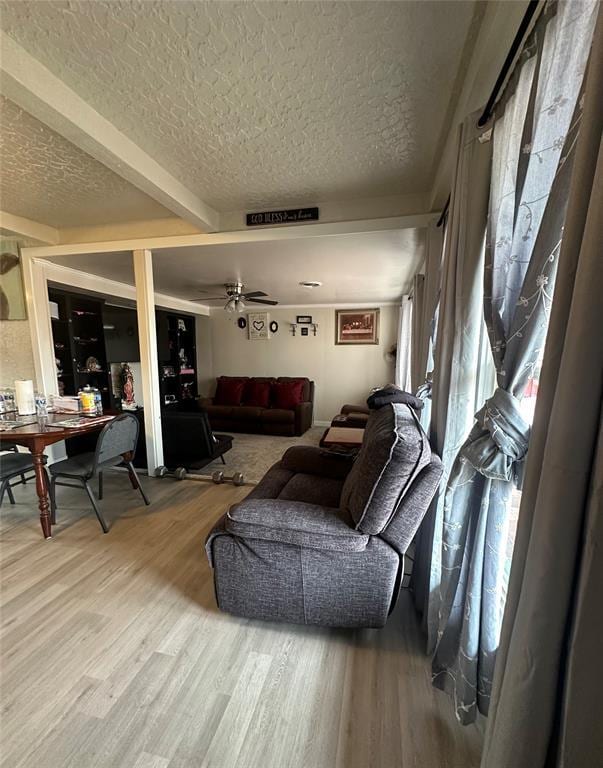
[341,403,431,535]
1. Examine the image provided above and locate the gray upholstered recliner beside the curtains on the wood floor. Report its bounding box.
[206,404,442,627]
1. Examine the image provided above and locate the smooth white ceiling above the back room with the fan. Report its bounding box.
[51,229,424,307]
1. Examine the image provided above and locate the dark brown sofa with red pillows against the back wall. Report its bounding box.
[199,376,314,435]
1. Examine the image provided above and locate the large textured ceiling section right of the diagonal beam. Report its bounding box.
[0,0,482,210]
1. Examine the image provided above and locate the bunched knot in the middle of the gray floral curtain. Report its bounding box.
[460,388,530,487]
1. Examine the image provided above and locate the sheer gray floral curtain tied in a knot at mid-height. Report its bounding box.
[433,0,596,723]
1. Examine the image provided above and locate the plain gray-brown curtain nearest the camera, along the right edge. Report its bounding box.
[481,7,603,768]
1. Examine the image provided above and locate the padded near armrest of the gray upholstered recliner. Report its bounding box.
[224,499,369,552]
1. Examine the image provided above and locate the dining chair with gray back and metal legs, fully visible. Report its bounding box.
[49,413,151,533]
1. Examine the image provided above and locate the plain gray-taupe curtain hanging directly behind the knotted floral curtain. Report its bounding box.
[412,112,492,640]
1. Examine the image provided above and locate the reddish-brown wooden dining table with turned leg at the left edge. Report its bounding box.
[0,413,115,539]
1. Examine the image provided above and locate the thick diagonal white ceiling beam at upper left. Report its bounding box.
[0,31,220,232]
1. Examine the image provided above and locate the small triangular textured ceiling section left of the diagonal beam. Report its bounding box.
[0,97,172,227]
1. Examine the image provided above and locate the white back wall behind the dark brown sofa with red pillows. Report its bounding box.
[211,306,398,422]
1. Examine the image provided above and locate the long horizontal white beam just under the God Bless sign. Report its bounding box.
[20,212,439,259]
